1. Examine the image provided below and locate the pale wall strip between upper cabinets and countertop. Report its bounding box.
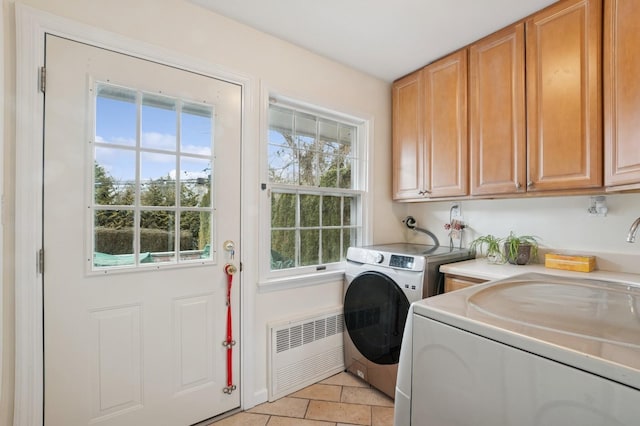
[406,193,640,274]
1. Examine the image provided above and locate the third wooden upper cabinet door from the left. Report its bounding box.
[469,23,527,195]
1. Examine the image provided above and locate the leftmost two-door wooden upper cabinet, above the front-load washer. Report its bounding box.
[392,49,468,201]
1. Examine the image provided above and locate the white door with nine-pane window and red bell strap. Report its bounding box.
[43,36,241,426]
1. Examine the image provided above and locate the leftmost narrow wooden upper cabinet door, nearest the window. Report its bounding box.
[392,71,426,200]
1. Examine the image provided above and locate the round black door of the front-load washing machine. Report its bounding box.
[344,271,409,364]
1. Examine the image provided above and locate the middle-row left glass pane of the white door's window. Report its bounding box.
[93,148,136,206]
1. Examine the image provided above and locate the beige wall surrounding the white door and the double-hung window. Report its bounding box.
[0,0,405,425]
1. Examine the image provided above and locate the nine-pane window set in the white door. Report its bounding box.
[87,82,215,272]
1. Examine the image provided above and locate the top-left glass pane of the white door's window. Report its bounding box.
[95,85,138,146]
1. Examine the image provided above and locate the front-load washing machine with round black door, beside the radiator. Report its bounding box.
[344,243,471,398]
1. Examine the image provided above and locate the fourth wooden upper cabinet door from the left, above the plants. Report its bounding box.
[526,0,602,191]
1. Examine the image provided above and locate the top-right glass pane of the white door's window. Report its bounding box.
[180,104,213,155]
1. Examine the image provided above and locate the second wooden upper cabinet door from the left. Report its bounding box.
[422,49,469,197]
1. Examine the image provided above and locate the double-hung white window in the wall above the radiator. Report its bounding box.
[267,99,366,277]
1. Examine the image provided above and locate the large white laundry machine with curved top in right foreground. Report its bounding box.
[394,274,640,426]
